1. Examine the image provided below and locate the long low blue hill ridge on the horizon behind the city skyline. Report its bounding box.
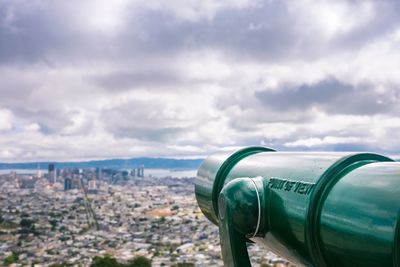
[0,157,203,170]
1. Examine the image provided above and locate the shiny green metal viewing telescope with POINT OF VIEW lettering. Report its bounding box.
[195,147,400,267]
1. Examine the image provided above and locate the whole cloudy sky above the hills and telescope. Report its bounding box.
[0,0,400,162]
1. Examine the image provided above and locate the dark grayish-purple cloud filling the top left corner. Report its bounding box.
[0,0,117,65]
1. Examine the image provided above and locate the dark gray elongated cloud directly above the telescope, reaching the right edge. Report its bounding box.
[256,79,400,115]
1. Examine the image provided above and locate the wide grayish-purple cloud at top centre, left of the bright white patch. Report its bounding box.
[124,1,296,58]
